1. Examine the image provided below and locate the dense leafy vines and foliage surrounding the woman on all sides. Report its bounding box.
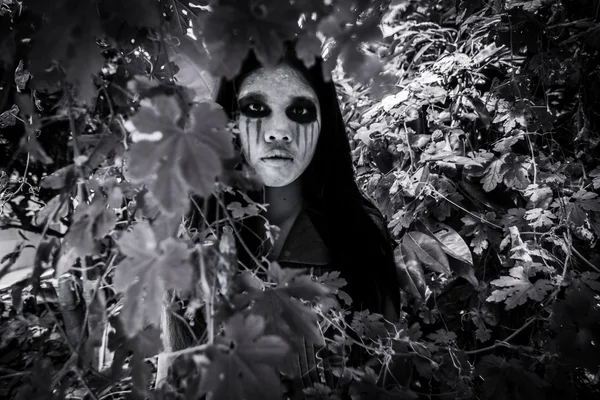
[0,0,600,399]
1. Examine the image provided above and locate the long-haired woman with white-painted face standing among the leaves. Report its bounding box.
[158,45,400,394]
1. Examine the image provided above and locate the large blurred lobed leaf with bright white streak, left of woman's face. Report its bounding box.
[126,95,233,214]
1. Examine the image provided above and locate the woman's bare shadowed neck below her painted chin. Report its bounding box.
[265,179,303,225]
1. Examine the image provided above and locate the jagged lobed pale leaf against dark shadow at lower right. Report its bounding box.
[486,266,554,310]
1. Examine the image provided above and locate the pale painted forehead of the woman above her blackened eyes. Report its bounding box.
[238,64,318,103]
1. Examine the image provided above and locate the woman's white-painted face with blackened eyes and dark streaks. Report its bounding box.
[237,64,321,187]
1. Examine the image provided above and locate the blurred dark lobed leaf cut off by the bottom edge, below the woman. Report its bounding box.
[196,313,289,400]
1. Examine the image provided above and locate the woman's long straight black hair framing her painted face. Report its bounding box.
[200,43,400,313]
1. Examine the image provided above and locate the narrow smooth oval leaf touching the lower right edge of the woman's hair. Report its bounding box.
[394,244,427,300]
